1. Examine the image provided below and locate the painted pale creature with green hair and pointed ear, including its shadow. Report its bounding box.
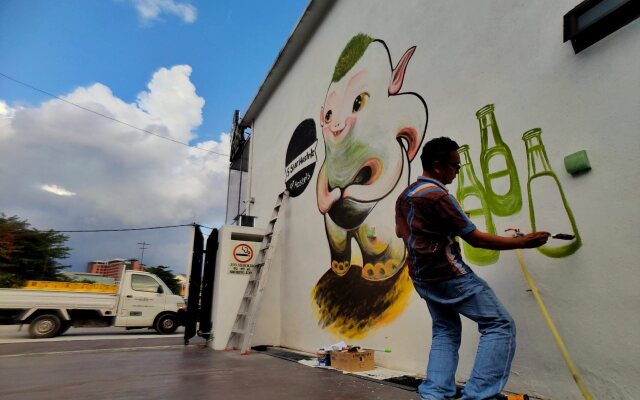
[312,34,428,338]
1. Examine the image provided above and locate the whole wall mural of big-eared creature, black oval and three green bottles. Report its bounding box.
[300,34,582,339]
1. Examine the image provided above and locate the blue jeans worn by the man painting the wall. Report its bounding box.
[413,273,516,400]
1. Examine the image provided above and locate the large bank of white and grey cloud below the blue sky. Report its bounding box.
[0,65,230,272]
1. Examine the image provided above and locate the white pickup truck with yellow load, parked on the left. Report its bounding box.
[0,271,187,339]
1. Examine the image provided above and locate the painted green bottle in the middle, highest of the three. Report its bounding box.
[476,104,522,217]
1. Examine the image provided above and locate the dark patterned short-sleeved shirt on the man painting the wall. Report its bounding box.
[396,176,476,282]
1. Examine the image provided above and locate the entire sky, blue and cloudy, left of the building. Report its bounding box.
[0,0,308,273]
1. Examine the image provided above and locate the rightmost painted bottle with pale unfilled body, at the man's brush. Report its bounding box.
[522,128,582,258]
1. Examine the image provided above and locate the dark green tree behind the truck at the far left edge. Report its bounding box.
[0,213,71,287]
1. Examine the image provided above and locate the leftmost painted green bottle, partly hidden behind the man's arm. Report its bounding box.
[456,144,500,265]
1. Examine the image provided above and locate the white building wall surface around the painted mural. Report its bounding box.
[241,0,640,399]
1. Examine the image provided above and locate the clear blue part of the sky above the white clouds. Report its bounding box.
[0,0,307,143]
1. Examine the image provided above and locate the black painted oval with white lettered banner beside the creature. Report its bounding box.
[284,118,318,197]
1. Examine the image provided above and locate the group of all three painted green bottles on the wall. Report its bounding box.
[456,104,582,266]
